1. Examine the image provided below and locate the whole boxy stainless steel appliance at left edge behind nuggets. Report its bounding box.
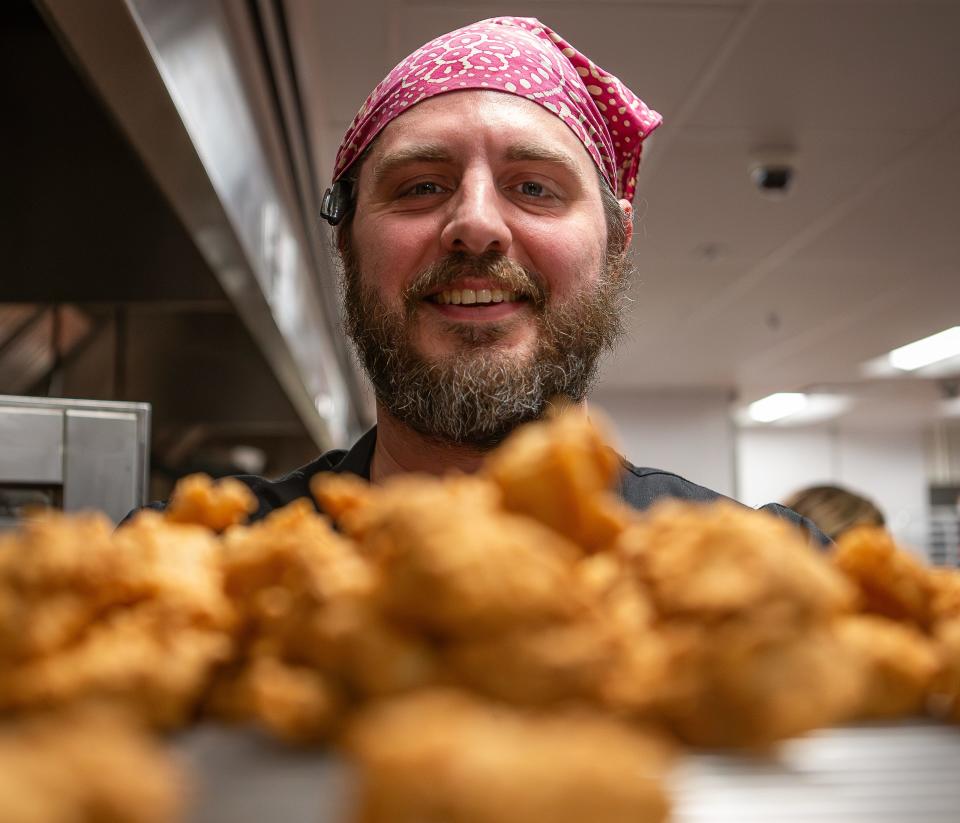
[0,395,150,521]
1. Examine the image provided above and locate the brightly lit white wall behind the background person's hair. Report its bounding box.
[736,425,929,551]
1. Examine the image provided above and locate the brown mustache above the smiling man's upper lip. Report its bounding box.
[403,251,549,310]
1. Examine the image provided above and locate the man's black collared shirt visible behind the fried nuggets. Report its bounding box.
[127,426,831,546]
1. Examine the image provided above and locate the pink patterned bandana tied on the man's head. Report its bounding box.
[333,17,663,200]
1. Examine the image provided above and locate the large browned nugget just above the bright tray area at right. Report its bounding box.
[658,619,863,749]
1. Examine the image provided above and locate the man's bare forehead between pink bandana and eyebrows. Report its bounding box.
[360,90,594,173]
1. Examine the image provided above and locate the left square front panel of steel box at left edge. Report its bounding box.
[0,406,63,483]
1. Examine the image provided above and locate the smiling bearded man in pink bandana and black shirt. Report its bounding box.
[142,17,824,540]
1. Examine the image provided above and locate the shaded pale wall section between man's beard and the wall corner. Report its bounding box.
[590,389,734,497]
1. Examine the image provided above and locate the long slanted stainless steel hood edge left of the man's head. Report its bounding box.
[39,0,357,447]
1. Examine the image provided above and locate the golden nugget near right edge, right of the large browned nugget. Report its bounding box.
[837,615,941,719]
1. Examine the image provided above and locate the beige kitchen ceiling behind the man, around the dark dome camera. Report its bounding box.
[283,0,960,418]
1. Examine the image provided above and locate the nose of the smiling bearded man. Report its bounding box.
[440,174,513,255]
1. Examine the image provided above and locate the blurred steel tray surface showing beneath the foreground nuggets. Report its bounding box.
[174,721,960,823]
